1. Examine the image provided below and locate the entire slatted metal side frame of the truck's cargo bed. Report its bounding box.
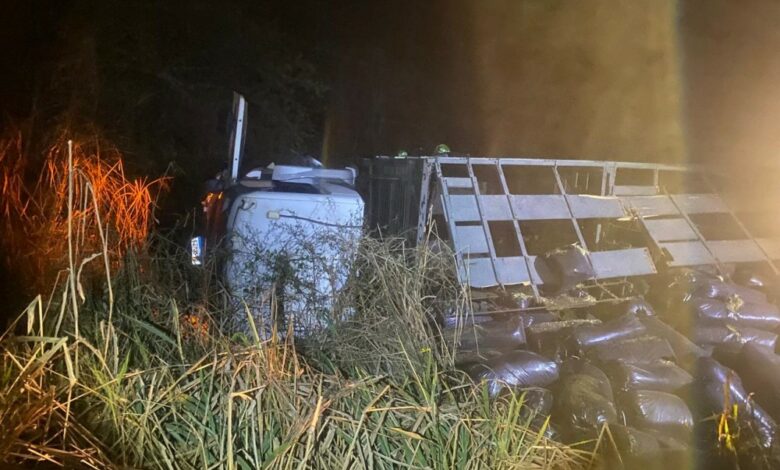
[417,156,780,295]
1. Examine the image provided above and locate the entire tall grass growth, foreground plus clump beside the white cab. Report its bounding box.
[0,134,588,469]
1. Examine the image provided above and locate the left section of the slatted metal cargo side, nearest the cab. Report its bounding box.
[435,157,656,291]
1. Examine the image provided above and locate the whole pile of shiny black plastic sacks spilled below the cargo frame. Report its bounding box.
[443,271,780,469]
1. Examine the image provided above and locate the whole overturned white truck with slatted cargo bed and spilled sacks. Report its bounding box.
[197,97,780,468]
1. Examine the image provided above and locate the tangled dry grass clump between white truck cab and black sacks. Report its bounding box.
[304,238,471,376]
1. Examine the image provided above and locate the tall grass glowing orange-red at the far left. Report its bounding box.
[0,129,169,298]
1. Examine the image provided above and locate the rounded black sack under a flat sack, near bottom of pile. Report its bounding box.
[619,390,693,442]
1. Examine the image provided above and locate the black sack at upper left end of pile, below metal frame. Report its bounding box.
[442,315,526,351]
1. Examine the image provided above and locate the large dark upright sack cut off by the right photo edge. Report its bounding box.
[737,342,780,420]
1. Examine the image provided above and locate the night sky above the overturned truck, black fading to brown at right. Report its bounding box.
[0,0,780,181]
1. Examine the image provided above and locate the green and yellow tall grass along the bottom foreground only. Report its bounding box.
[0,302,583,468]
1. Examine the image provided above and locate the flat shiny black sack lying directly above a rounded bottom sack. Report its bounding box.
[605,361,693,393]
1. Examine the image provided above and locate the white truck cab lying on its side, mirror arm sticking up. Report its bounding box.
[191,92,364,337]
